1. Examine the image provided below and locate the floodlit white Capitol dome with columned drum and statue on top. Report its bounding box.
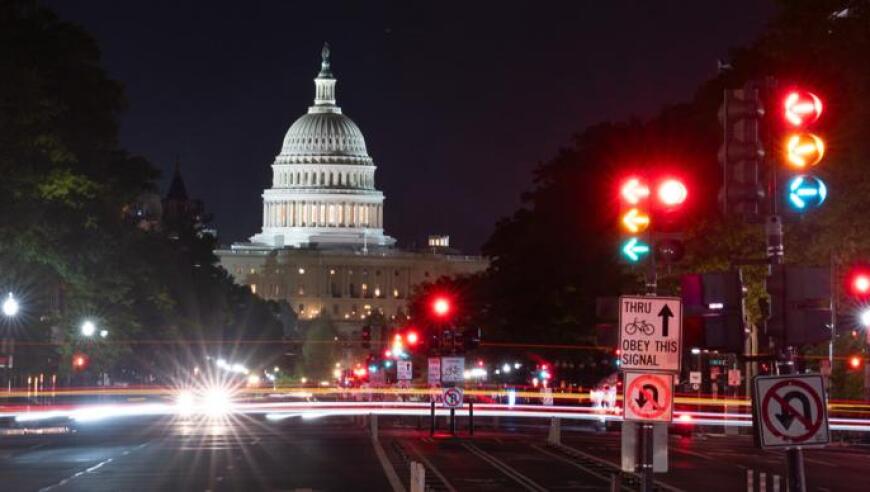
[251,45,396,251]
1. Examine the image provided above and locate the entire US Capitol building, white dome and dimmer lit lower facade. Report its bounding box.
[215,45,488,324]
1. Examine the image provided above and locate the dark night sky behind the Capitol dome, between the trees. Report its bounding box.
[44,0,775,252]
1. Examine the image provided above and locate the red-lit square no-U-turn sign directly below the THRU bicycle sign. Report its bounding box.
[623,372,674,422]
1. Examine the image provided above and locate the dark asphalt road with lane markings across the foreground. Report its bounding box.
[0,417,870,492]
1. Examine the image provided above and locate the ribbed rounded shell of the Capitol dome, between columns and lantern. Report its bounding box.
[281,111,368,157]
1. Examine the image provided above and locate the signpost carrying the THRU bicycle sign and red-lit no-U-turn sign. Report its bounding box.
[619,294,683,492]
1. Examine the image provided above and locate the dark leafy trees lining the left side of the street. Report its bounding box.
[0,0,281,378]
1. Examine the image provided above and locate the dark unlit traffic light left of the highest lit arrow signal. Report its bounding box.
[719,83,768,218]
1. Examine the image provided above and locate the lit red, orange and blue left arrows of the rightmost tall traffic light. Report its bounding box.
[781,90,828,213]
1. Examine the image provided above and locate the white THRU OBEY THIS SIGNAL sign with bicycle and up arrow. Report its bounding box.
[619,296,683,372]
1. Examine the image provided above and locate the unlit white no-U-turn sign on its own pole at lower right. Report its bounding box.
[752,374,831,449]
